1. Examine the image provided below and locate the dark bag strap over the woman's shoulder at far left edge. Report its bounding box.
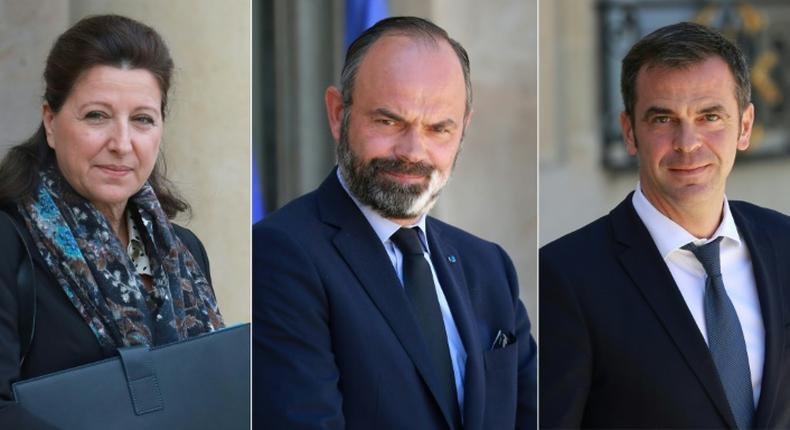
[0,210,36,367]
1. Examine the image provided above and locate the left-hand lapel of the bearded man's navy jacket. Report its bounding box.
[318,170,460,425]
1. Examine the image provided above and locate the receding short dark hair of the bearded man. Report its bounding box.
[340,16,472,116]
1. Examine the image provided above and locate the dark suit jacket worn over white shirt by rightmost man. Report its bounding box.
[539,195,790,428]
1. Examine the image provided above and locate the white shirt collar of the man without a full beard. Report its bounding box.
[631,182,741,259]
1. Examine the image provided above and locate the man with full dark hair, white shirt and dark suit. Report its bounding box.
[540,23,790,429]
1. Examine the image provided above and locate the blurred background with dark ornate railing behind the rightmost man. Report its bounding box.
[539,0,790,245]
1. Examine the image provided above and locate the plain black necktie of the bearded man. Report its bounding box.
[390,227,460,425]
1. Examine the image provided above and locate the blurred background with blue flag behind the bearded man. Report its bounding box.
[252,0,537,330]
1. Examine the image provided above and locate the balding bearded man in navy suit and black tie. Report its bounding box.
[253,17,537,430]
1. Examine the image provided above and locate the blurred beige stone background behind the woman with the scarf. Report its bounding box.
[0,0,250,323]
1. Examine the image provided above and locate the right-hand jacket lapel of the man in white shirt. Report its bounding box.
[730,202,786,428]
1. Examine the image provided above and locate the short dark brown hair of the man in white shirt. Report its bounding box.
[620,22,752,120]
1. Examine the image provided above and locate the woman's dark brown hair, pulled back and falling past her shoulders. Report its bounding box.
[0,15,190,218]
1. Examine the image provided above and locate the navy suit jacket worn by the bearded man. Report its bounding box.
[253,171,537,430]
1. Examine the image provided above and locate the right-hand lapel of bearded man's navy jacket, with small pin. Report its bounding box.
[427,222,485,429]
